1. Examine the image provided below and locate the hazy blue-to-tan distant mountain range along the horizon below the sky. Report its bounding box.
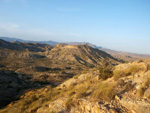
[0,37,150,61]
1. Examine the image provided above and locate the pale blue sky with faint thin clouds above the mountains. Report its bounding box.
[0,0,150,54]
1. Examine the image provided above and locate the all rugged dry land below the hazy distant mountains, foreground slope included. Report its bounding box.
[0,40,150,113]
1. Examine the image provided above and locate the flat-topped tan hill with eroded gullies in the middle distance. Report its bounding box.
[47,44,119,66]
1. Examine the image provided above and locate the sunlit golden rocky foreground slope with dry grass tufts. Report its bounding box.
[0,60,150,113]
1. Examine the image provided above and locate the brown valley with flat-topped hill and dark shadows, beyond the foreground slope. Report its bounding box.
[0,40,119,107]
